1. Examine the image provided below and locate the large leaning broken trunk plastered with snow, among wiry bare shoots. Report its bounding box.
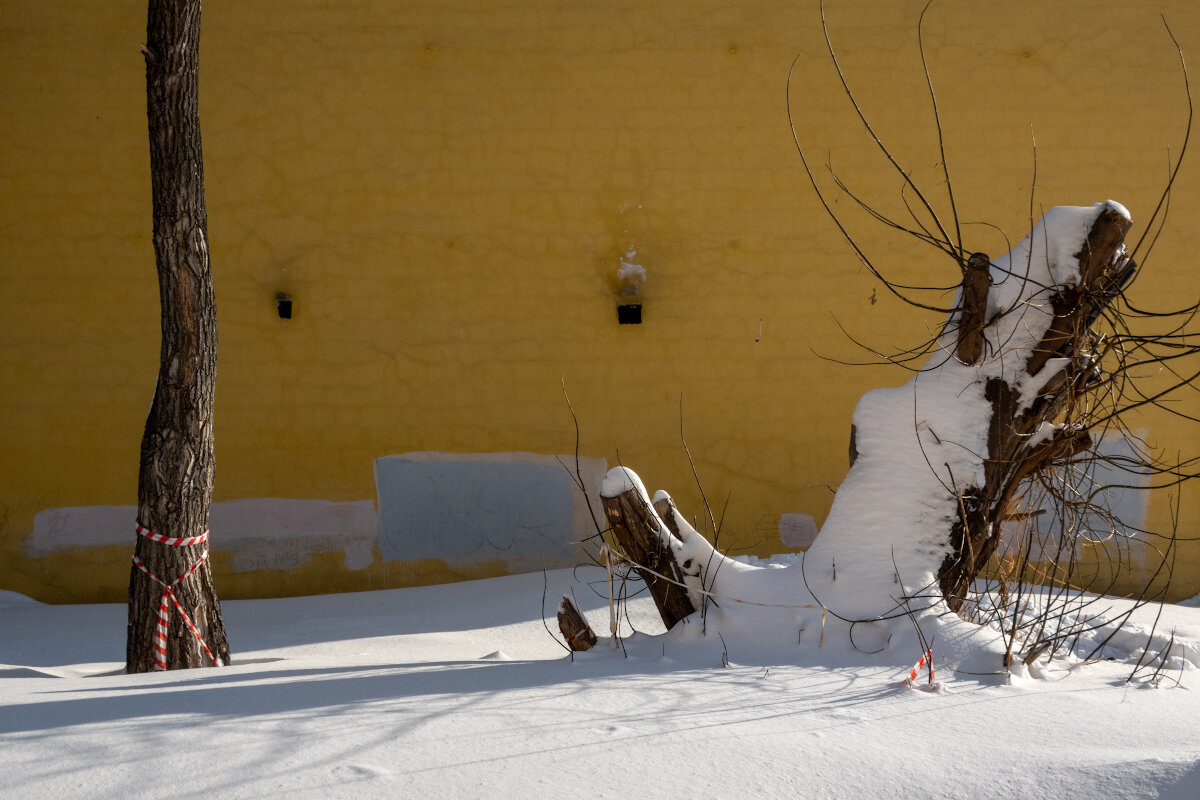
[806,201,1134,619]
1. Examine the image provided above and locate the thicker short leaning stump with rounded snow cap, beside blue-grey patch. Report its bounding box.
[600,468,696,631]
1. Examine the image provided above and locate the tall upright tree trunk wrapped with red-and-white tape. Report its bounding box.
[125,0,229,673]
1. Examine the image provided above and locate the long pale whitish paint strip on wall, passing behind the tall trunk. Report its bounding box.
[24,498,379,572]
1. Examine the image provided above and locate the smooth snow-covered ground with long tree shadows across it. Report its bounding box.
[0,571,1200,800]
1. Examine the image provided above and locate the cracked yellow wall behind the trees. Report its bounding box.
[0,0,1200,601]
